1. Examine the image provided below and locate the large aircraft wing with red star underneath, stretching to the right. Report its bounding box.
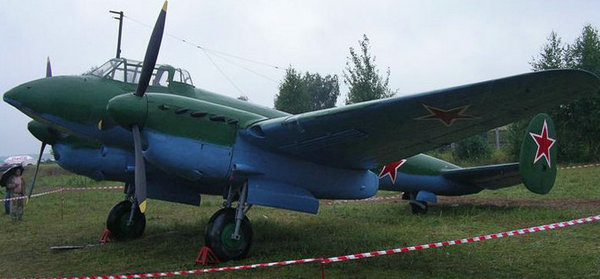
[242,70,600,169]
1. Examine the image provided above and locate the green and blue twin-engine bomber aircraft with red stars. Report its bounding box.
[4,2,600,261]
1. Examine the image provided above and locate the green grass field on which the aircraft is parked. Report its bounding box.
[0,166,600,278]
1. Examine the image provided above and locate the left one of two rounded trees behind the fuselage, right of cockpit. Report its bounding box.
[275,66,310,114]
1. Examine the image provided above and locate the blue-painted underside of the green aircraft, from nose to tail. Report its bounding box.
[7,95,548,213]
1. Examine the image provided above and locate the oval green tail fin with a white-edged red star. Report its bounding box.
[519,113,557,194]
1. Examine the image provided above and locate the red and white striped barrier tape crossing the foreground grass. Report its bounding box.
[50,215,600,279]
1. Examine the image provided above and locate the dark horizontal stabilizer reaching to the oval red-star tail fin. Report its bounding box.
[442,163,522,190]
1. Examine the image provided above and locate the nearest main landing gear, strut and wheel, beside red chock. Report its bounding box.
[204,183,252,262]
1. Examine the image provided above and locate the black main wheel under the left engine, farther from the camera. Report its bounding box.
[106,200,146,240]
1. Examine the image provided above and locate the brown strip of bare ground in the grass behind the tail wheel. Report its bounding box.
[323,195,600,209]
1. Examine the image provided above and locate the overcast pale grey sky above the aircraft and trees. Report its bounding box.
[0,0,600,155]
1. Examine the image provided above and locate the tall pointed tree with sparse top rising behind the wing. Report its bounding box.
[343,35,396,104]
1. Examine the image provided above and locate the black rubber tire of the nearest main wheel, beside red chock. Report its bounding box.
[204,208,252,262]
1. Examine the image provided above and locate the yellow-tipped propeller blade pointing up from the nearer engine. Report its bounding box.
[135,1,167,97]
